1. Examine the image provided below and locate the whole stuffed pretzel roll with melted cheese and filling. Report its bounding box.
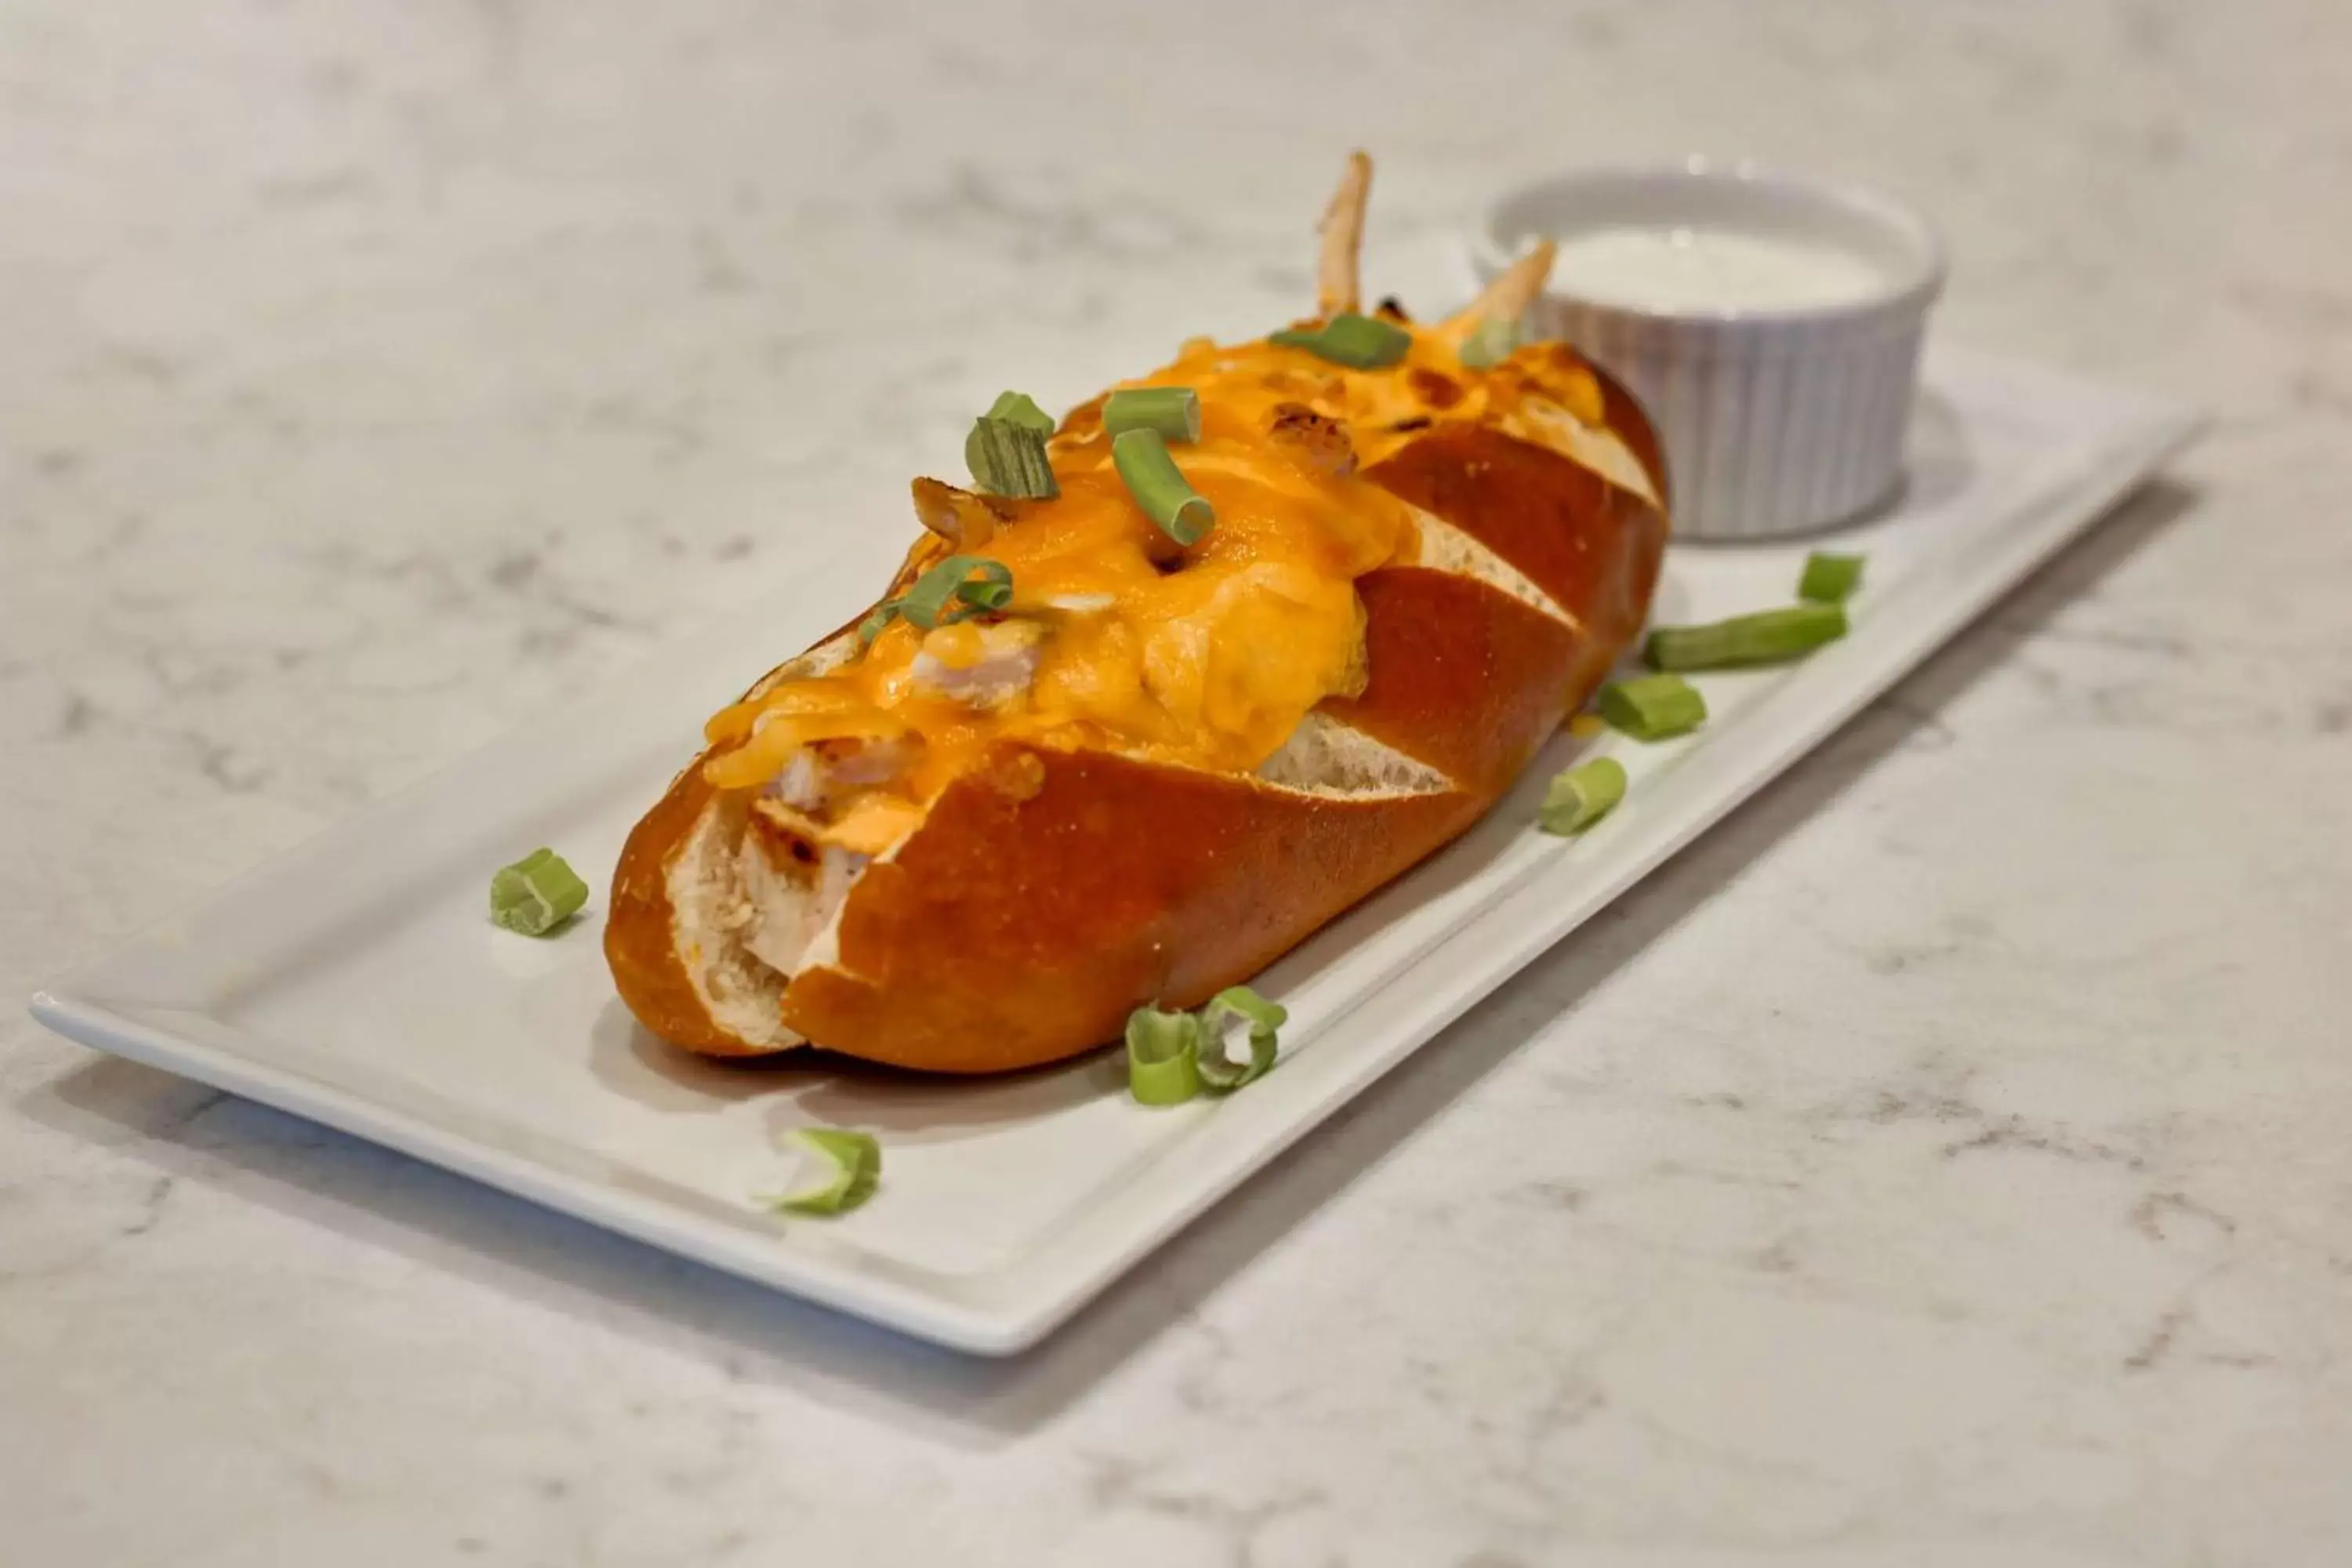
[604,155,1668,1072]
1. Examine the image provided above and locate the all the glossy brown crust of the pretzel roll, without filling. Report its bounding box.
[604,355,1668,1072]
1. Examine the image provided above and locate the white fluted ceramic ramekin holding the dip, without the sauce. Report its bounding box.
[1470,158,1945,539]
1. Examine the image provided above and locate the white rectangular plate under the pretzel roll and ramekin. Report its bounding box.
[33,353,2194,1354]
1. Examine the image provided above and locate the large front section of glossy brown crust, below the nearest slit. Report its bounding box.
[783,753,1479,1072]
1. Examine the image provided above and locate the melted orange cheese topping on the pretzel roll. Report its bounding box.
[706,332,1599,853]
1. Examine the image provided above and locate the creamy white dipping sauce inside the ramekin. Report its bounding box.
[1552,226,1886,313]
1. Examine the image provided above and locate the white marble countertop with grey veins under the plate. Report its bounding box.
[0,0,2352,1568]
